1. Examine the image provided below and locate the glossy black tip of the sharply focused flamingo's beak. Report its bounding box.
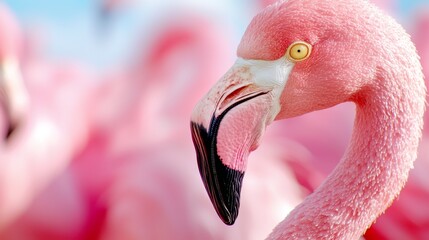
[191,122,244,225]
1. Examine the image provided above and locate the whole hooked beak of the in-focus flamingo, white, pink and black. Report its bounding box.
[191,58,293,225]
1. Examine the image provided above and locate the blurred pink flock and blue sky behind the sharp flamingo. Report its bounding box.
[0,0,429,240]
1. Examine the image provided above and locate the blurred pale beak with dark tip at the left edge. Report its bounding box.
[0,58,29,139]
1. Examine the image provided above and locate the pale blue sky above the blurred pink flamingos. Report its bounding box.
[4,0,429,70]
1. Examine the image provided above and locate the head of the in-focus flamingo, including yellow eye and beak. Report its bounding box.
[191,0,415,225]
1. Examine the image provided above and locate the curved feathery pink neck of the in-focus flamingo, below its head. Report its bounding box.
[269,70,425,239]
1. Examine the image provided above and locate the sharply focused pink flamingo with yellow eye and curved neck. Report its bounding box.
[191,0,426,239]
